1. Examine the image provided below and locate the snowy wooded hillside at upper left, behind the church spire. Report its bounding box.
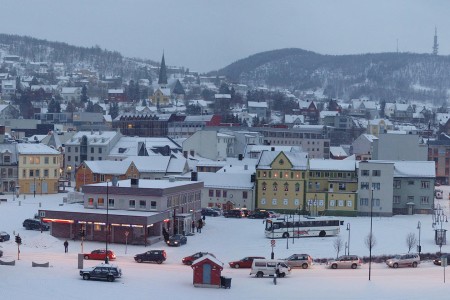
[0,34,157,78]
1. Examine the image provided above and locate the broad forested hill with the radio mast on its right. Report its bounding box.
[218,48,450,104]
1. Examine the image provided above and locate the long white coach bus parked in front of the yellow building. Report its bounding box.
[265,217,344,239]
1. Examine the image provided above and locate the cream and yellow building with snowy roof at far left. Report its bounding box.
[17,144,62,194]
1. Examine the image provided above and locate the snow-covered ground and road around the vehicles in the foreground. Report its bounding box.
[0,186,450,300]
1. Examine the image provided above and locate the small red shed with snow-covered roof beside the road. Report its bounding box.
[191,254,223,288]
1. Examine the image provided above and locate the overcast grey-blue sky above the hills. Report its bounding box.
[0,0,450,72]
